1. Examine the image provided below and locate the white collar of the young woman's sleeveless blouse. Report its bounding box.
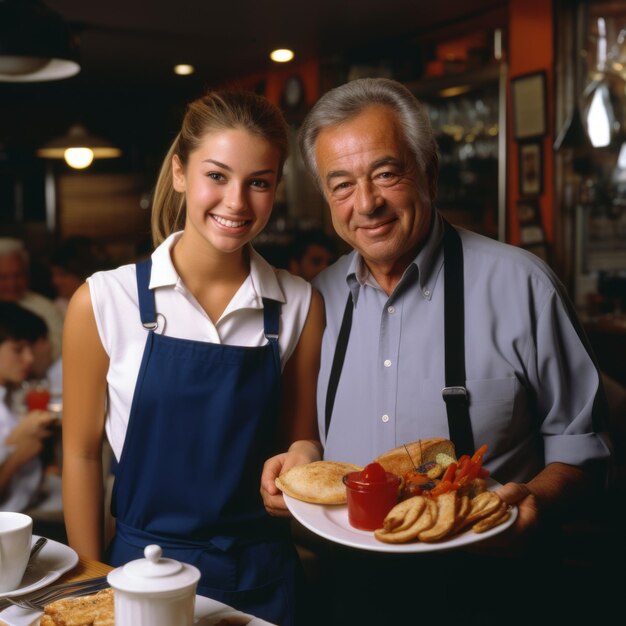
[145,231,286,308]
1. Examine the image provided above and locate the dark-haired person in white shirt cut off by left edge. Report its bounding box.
[0,302,52,511]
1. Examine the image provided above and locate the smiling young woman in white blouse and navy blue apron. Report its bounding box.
[63,92,323,624]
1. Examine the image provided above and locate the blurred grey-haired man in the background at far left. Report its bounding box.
[0,237,63,370]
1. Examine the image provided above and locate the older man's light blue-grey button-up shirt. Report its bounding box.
[314,215,609,482]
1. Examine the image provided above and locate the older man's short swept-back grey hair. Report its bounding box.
[298,78,439,202]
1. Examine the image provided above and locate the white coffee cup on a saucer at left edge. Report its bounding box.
[0,511,33,593]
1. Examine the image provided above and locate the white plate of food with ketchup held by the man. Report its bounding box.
[276,438,517,552]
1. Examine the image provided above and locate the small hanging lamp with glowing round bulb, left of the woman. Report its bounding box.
[37,124,122,169]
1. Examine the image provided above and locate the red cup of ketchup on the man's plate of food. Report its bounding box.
[343,463,400,530]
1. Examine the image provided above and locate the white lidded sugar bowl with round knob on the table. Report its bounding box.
[107,545,200,626]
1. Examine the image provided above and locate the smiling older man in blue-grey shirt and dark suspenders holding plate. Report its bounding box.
[262,79,610,623]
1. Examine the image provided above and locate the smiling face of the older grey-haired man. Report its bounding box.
[315,105,431,275]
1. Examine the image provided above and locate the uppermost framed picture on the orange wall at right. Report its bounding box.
[511,72,548,141]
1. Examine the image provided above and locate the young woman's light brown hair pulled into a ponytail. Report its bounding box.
[152,91,289,246]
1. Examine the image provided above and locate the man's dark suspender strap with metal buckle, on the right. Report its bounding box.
[441,220,474,457]
